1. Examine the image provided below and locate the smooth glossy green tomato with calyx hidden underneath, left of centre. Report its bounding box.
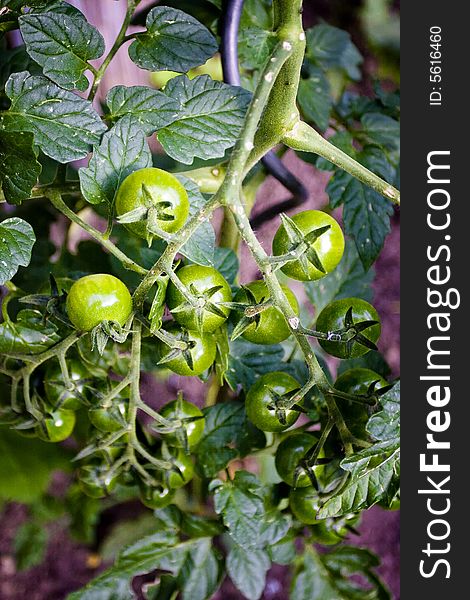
[66,274,132,331]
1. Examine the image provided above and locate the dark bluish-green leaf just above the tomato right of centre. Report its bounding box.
[225,338,284,390]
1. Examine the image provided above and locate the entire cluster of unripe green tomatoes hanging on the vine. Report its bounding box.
[26,168,387,516]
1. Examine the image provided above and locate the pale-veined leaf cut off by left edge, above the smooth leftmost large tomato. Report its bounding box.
[0,218,36,285]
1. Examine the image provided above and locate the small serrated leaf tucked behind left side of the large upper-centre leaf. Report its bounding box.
[106,85,180,135]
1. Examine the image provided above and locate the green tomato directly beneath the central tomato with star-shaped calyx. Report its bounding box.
[157,325,217,377]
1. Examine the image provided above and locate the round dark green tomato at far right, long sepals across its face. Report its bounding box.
[315,298,380,358]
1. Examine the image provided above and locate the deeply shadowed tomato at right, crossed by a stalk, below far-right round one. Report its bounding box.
[334,368,388,439]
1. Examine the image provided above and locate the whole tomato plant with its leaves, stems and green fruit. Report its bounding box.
[0,0,400,600]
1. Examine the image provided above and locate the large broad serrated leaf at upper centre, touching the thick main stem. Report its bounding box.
[158,75,250,165]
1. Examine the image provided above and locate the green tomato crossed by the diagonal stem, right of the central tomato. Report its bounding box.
[235,281,299,344]
